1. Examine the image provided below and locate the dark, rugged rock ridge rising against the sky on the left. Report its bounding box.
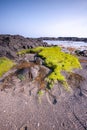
[0,35,48,59]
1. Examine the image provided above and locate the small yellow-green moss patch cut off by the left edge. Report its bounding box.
[0,57,14,77]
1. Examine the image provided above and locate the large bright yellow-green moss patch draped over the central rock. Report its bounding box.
[17,46,81,88]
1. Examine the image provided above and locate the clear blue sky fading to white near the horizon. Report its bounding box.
[0,0,87,37]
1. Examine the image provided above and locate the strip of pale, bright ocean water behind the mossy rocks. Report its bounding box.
[43,40,87,50]
